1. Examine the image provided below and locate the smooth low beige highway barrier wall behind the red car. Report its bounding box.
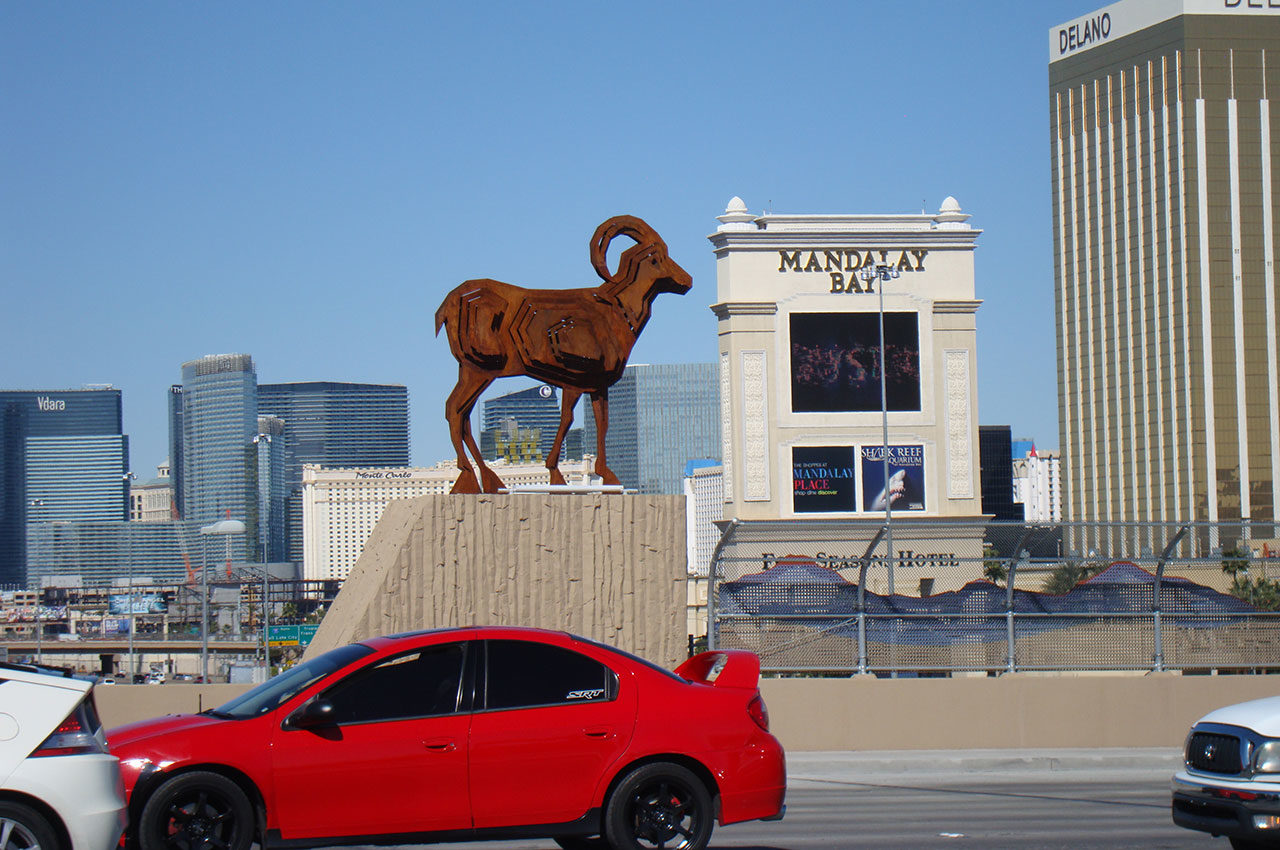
[95,673,1280,751]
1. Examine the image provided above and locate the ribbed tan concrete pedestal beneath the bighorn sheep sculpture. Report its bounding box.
[307,494,687,666]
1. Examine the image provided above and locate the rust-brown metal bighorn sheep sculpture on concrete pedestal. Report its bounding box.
[435,215,694,493]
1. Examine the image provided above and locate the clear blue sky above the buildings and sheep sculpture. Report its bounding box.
[0,0,1105,477]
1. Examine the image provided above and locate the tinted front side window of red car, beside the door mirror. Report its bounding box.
[324,644,463,723]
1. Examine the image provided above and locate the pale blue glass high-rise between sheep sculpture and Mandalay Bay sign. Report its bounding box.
[579,364,721,495]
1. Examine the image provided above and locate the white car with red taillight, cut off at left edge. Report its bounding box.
[0,662,127,850]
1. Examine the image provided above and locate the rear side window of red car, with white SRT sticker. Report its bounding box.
[485,640,618,709]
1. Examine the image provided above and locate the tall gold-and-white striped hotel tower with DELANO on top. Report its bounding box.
[1048,0,1280,545]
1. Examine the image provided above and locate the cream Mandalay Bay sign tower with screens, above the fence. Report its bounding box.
[709,198,982,520]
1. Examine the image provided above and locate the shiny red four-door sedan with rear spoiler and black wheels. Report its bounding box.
[109,627,786,850]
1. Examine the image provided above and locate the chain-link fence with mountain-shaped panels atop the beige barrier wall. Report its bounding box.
[708,517,1280,676]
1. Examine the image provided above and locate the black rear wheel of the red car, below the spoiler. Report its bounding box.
[604,762,714,850]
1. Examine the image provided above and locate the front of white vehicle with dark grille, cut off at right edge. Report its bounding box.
[1172,696,1280,850]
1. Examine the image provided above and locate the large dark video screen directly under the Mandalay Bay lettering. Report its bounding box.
[791,312,920,413]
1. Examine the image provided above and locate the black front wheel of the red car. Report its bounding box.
[138,771,253,850]
